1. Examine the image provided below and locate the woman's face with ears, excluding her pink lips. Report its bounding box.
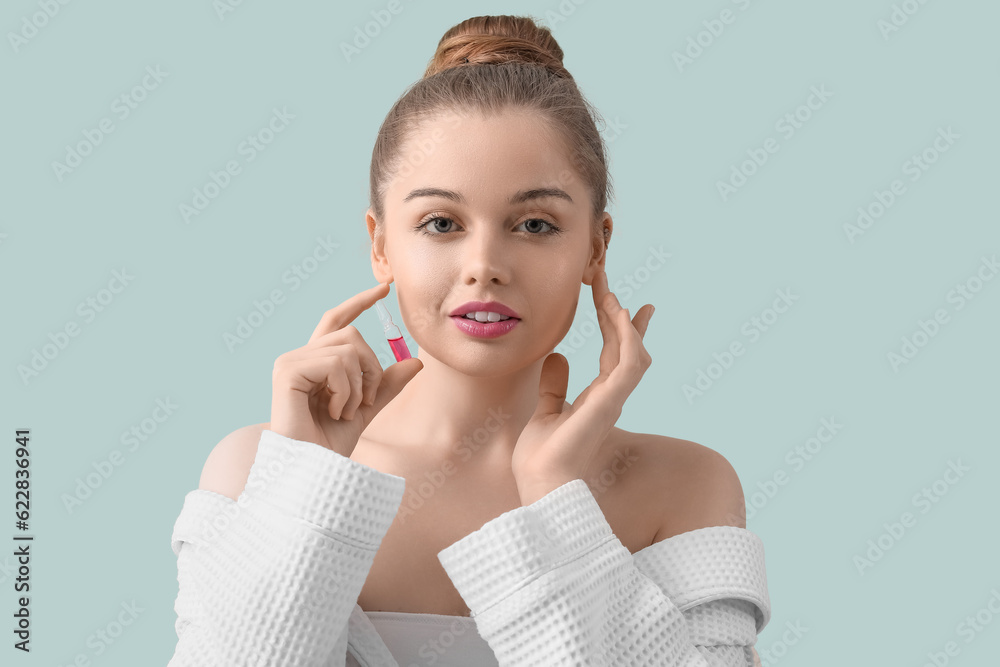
[369,112,611,376]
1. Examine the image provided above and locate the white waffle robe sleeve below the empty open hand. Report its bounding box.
[438,479,771,667]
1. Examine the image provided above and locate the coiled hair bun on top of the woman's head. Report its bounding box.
[424,15,573,79]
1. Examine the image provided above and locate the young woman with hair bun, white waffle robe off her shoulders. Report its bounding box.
[170,16,770,667]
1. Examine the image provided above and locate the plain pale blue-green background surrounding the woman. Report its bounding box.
[0,0,1000,667]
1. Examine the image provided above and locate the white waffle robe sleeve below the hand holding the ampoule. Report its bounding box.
[168,430,406,667]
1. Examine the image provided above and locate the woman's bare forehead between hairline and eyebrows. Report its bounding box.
[387,111,586,205]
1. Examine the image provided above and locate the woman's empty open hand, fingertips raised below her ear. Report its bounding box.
[511,269,654,505]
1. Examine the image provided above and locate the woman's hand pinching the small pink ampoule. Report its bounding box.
[270,283,424,457]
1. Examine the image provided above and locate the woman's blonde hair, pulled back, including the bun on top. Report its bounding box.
[369,15,613,245]
